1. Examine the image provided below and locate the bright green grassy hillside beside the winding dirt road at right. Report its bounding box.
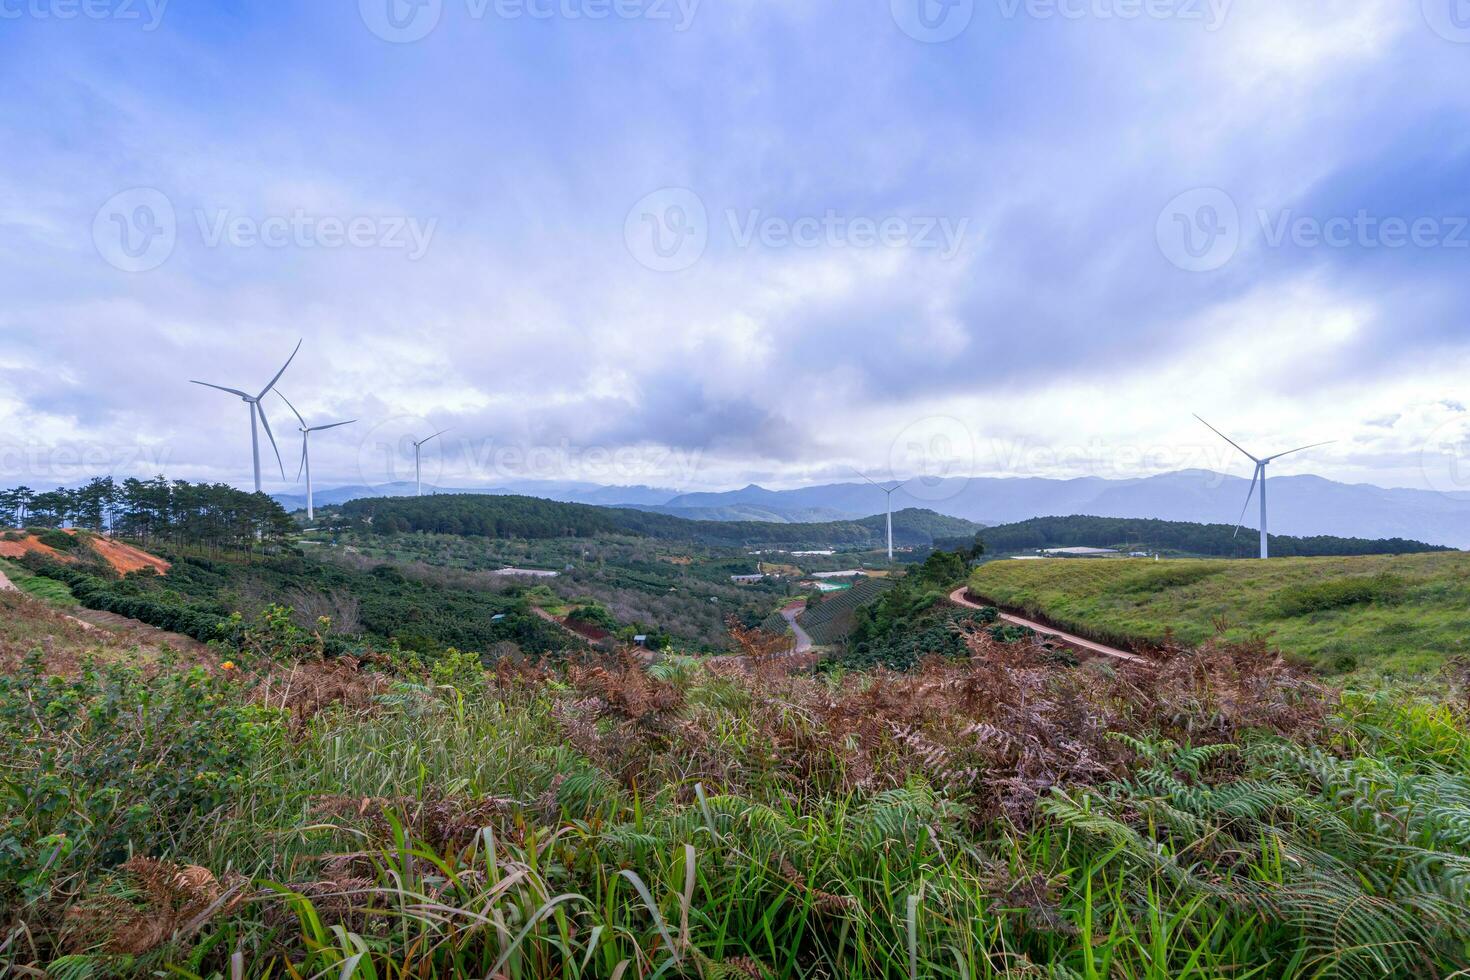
[970,552,1470,673]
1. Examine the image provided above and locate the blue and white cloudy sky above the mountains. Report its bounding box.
[0,0,1470,489]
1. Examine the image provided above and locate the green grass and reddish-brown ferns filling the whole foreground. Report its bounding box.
[0,597,1470,980]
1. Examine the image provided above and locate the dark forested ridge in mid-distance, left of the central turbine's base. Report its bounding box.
[341,494,979,548]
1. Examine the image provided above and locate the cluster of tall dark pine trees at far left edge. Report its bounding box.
[0,476,293,551]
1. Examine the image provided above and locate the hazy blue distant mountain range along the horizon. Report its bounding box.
[276,470,1470,550]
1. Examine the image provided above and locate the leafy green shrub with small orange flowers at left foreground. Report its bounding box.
[0,654,276,914]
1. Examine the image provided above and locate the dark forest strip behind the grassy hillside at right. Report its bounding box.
[964,516,1451,558]
